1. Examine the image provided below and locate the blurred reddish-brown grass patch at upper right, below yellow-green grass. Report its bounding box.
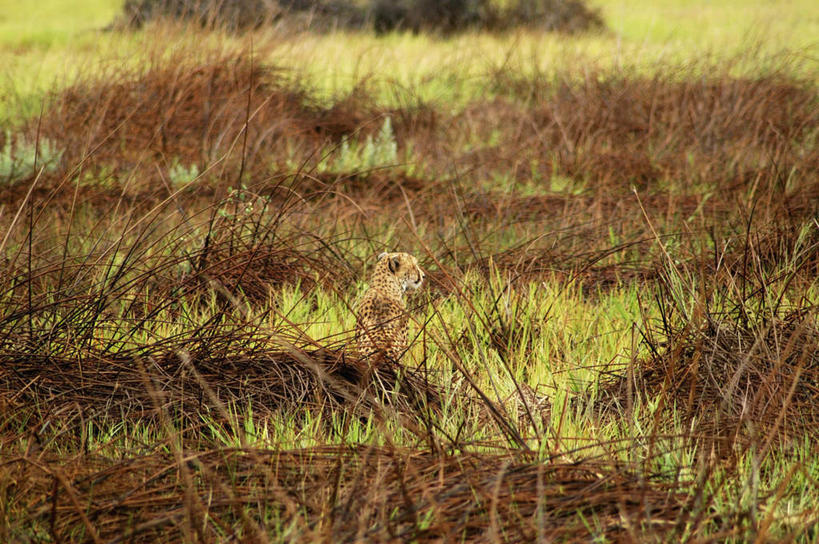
[478,72,819,198]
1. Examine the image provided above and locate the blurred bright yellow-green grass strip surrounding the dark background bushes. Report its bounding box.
[0,0,819,120]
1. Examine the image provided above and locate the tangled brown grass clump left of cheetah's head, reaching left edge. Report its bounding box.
[0,194,348,324]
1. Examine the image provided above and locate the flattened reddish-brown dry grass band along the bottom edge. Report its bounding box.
[4,447,686,542]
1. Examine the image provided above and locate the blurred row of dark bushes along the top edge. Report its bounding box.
[121,0,603,33]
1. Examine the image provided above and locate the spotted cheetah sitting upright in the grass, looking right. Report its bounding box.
[356,253,424,366]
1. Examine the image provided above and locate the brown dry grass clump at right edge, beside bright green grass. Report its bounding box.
[601,315,819,455]
